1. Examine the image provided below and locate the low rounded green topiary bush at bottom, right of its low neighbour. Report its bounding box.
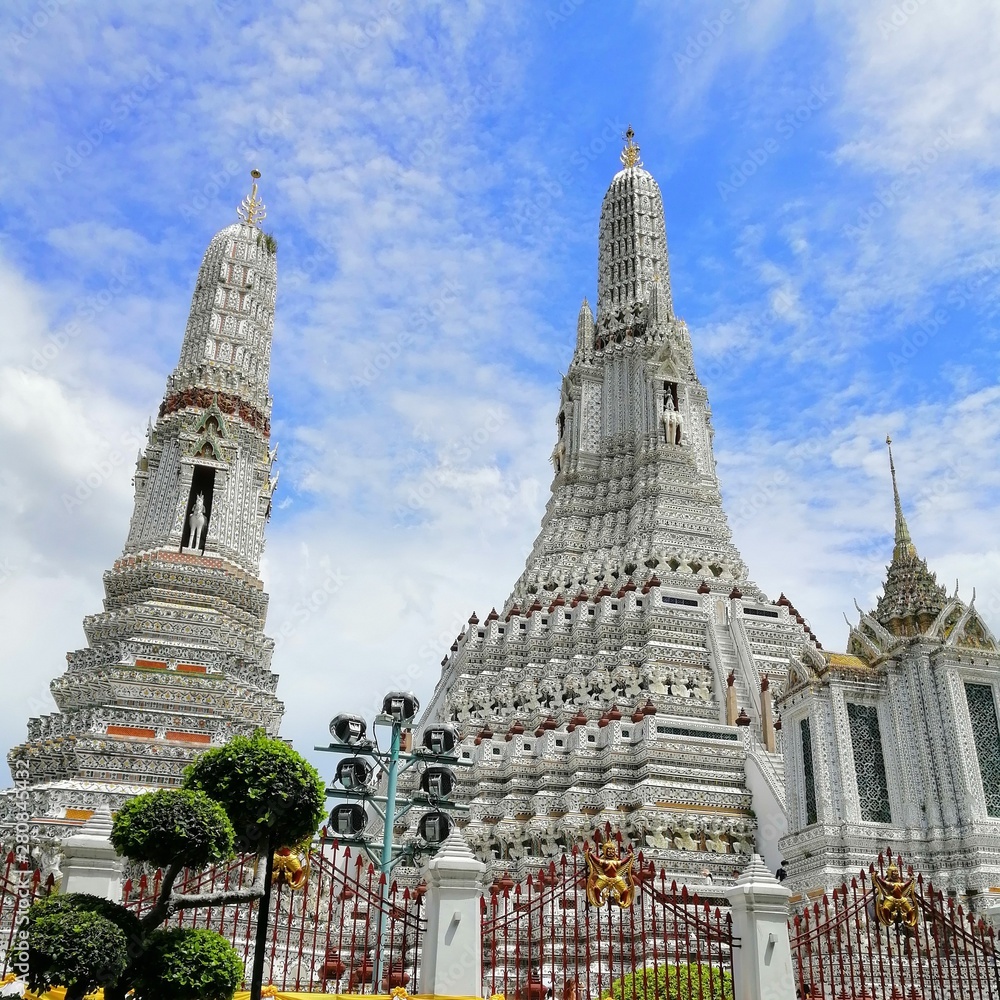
[133,927,243,1000]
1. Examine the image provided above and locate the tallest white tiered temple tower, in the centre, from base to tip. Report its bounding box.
[404,132,822,881]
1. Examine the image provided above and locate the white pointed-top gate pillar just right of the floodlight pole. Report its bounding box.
[420,826,486,997]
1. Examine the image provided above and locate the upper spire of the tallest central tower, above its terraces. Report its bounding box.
[511,128,759,607]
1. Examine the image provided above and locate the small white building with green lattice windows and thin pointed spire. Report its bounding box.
[778,438,1000,909]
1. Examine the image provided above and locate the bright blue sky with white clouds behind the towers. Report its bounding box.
[0,0,1000,772]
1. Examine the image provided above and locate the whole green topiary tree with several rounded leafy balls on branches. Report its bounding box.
[29,731,325,1000]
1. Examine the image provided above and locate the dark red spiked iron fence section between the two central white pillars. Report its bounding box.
[481,828,734,1000]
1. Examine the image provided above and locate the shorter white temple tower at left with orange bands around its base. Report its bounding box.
[0,172,283,838]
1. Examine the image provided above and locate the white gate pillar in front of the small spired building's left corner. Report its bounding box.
[726,854,795,1000]
